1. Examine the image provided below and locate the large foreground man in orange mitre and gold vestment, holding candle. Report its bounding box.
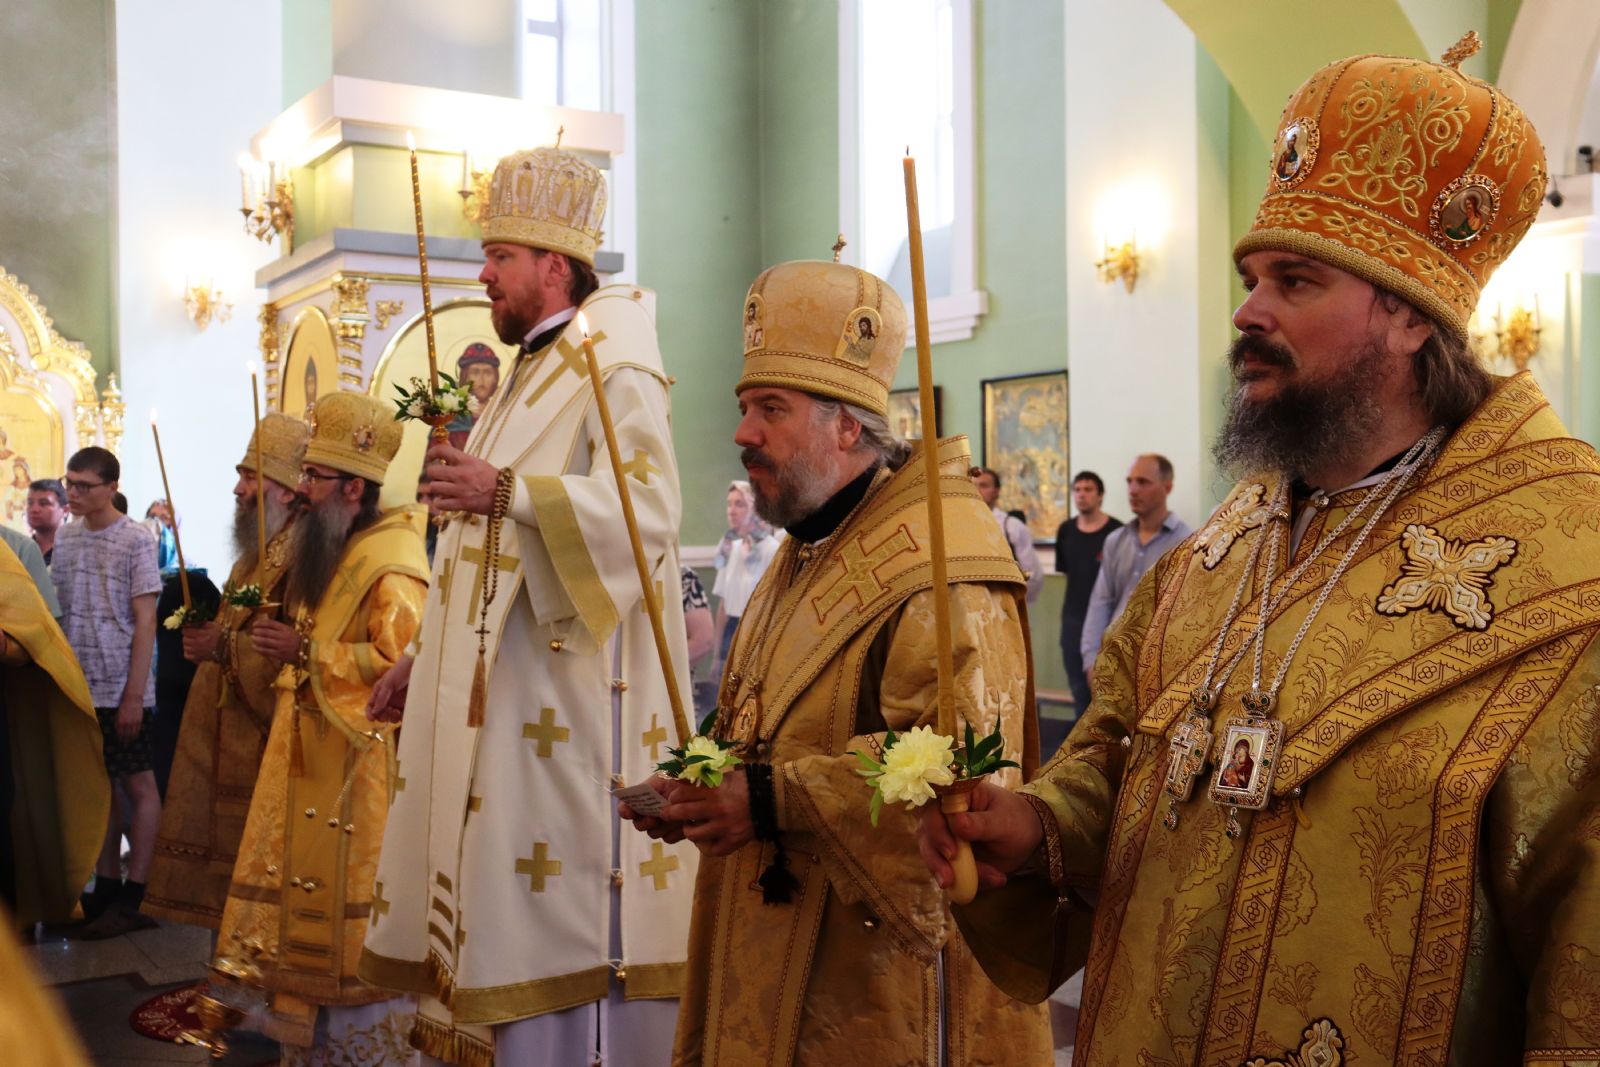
[923,31,1600,1067]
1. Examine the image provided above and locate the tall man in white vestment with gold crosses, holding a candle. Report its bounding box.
[360,149,696,1067]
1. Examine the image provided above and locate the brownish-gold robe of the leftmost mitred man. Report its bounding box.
[144,530,290,929]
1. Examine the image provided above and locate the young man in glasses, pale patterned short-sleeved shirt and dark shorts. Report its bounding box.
[51,446,162,939]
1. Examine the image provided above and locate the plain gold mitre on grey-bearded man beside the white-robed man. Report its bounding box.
[734,259,906,414]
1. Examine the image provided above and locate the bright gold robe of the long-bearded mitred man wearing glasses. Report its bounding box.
[218,507,427,1045]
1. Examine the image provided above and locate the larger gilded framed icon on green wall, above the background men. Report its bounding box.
[979,370,1072,545]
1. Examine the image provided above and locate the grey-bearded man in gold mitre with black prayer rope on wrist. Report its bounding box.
[620,262,1054,1067]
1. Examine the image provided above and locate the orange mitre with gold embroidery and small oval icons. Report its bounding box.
[1234,34,1549,339]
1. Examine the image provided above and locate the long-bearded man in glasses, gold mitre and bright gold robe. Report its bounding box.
[216,392,427,1067]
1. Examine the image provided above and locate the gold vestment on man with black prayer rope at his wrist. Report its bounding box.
[674,438,1051,1067]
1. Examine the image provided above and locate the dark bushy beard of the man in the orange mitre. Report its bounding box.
[1211,342,1386,488]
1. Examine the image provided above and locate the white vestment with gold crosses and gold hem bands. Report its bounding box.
[360,286,696,1062]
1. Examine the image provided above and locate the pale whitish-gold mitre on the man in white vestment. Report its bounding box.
[483,149,605,267]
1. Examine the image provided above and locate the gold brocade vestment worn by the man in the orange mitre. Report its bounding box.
[958,374,1600,1067]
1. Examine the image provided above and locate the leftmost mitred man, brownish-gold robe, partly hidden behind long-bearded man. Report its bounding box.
[144,411,310,929]
